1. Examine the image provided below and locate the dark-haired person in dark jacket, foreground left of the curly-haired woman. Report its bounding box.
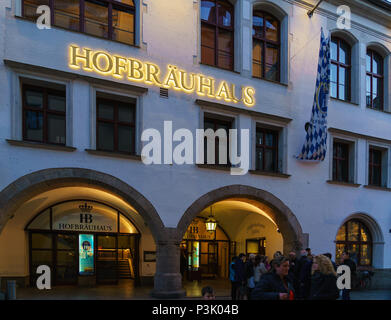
[251,256,295,300]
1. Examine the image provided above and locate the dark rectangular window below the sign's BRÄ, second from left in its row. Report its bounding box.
[96,96,136,154]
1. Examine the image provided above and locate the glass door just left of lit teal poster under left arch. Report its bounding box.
[55,234,78,284]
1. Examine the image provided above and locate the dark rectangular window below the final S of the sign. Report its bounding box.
[255,128,278,172]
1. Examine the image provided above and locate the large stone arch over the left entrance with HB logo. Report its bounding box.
[0,168,165,243]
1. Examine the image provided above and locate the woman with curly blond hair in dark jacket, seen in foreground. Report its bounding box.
[309,255,339,300]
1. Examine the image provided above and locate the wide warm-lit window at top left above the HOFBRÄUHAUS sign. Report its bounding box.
[23,0,135,45]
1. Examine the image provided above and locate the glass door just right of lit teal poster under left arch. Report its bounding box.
[96,235,118,284]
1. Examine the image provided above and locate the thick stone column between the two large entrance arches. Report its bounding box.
[152,234,185,299]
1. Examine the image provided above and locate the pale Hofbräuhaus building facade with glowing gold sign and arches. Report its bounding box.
[0,0,391,297]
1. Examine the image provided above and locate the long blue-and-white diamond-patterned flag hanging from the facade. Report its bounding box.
[297,29,330,161]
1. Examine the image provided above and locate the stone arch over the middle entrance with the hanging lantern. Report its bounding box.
[177,185,305,253]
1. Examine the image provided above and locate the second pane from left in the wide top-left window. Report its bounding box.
[54,0,80,30]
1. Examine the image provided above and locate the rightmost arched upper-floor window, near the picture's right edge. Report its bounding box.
[366,49,384,110]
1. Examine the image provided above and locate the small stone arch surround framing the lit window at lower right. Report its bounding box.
[334,212,384,268]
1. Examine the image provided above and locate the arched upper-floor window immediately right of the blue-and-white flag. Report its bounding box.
[330,37,352,101]
